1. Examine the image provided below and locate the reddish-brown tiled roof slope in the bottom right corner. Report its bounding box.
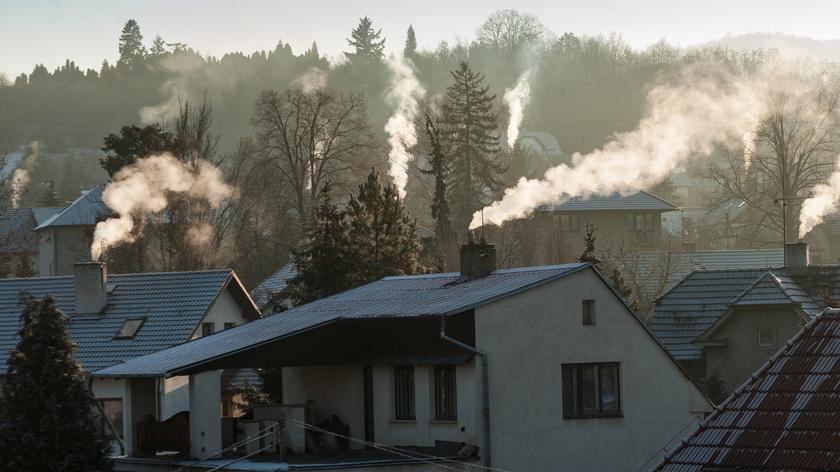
[656,309,840,472]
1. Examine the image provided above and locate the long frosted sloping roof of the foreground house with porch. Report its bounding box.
[95,263,591,377]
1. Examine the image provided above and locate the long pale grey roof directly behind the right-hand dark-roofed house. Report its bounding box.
[634,249,785,300]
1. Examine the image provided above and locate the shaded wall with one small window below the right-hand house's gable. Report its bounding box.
[703,307,802,393]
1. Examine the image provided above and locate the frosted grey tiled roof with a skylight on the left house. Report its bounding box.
[0,269,257,373]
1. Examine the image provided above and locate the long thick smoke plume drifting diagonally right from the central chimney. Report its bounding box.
[470,64,776,228]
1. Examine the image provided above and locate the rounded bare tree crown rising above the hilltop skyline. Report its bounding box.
[477,10,546,55]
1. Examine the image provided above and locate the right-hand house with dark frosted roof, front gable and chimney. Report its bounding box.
[651,243,840,391]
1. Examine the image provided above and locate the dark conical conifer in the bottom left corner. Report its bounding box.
[0,297,111,472]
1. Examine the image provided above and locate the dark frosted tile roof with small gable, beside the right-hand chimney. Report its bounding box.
[650,269,823,360]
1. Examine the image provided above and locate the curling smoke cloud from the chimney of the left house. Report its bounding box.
[90,154,233,260]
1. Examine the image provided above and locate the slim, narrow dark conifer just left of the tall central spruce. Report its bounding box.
[421,113,455,270]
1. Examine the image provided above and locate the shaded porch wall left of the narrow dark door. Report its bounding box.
[283,366,365,449]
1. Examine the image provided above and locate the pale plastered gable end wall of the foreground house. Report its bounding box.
[475,270,711,471]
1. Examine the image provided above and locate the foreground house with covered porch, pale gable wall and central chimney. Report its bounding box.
[94,243,711,471]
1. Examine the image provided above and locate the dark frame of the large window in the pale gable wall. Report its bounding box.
[561,362,624,419]
